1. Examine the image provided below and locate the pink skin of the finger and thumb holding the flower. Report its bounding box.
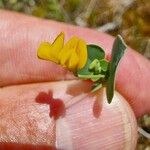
[0,10,150,149]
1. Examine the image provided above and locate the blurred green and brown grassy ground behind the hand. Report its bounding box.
[0,0,150,150]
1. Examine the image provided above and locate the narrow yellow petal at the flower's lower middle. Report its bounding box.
[68,49,79,72]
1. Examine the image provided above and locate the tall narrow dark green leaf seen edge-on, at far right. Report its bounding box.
[106,35,126,103]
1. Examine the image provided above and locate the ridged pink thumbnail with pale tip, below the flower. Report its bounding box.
[56,88,137,150]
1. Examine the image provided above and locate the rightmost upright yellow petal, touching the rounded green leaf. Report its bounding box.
[76,39,88,69]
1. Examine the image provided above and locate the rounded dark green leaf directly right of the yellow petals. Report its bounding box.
[87,44,105,62]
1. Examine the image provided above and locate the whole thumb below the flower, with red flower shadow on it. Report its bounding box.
[0,80,137,150]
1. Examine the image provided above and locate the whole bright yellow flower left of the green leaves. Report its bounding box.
[38,33,87,72]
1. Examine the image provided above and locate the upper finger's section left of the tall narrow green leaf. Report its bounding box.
[0,11,113,86]
